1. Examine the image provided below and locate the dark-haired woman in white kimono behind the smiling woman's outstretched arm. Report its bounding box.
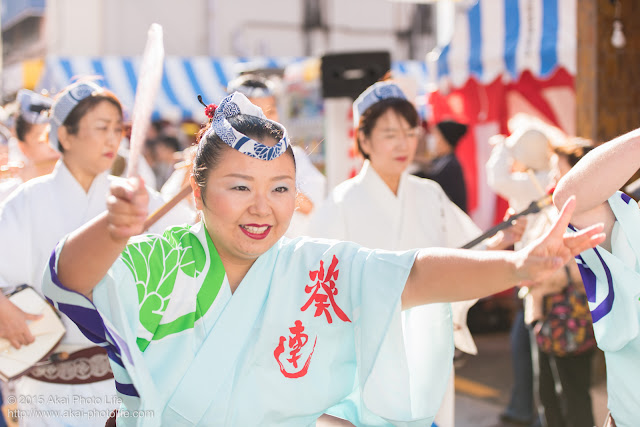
[309,82,521,427]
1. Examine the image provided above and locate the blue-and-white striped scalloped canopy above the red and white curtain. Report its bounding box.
[437,0,577,87]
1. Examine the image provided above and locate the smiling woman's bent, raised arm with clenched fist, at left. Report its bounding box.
[58,178,149,298]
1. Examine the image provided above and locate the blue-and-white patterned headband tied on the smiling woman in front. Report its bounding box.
[204,92,289,160]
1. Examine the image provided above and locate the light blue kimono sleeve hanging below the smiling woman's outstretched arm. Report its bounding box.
[328,243,454,426]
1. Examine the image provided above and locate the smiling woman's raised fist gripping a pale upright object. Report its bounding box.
[107,177,149,241]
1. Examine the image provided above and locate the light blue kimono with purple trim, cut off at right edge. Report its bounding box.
[577,192,640,427]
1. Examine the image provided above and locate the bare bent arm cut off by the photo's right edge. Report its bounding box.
[553,129,640,242]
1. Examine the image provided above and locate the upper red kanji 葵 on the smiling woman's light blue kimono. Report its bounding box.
[300,255,351,323]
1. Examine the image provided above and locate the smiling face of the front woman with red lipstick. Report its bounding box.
[192,147,296,262]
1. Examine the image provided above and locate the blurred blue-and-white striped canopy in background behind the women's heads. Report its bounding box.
[38,56,427,121]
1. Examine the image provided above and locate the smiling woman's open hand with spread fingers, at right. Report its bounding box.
[517,197,606,286]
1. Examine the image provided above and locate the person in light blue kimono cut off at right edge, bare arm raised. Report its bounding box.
[554,129,640,427]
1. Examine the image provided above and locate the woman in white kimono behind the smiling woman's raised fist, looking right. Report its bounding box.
[0,82,191,426]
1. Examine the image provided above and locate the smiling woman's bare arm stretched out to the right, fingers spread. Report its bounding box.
[402,198,605,309]
